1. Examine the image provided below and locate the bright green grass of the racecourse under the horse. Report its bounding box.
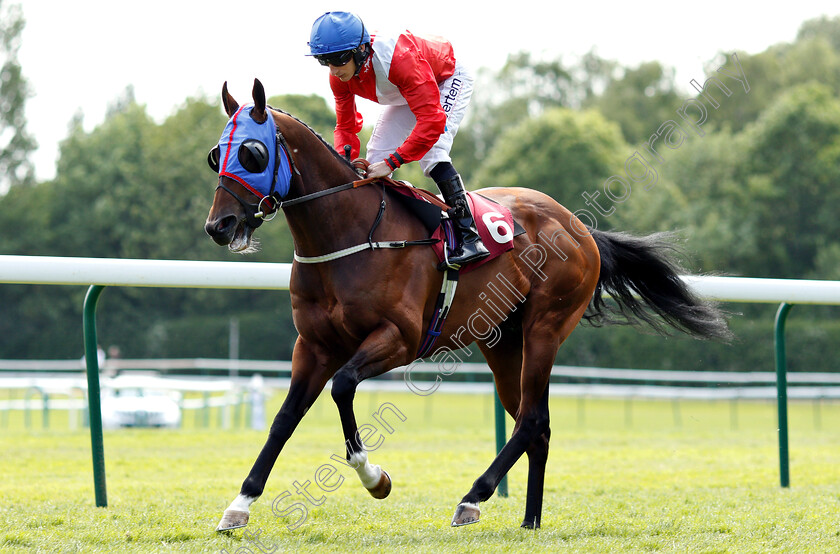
[0,393,840,553]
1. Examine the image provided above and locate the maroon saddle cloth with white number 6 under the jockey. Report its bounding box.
[389,181,525,273]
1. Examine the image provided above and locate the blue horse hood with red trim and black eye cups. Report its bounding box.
[219,104,292,199]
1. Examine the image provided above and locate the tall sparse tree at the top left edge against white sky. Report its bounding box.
[0,0,36,193]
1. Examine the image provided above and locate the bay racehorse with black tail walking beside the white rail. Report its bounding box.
[205,80,729,531]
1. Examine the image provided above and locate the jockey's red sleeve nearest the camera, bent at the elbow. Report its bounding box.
[388,35,446,163]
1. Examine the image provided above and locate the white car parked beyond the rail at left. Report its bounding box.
[102,388,181,429]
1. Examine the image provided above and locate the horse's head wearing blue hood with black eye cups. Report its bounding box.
[204,79,292,252]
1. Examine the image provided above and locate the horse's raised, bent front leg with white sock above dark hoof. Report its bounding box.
[332,323,408,498]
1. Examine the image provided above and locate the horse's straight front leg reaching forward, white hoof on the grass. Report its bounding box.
[216,339,330,531]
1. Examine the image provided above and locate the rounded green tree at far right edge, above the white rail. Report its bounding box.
[745,83,840,278]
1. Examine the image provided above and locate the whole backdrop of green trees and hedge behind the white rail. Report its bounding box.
[0,12,840,371]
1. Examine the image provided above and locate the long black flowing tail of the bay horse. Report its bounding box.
[584,225,732,341]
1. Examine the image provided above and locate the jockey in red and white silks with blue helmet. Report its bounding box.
[309,12,489,266]
